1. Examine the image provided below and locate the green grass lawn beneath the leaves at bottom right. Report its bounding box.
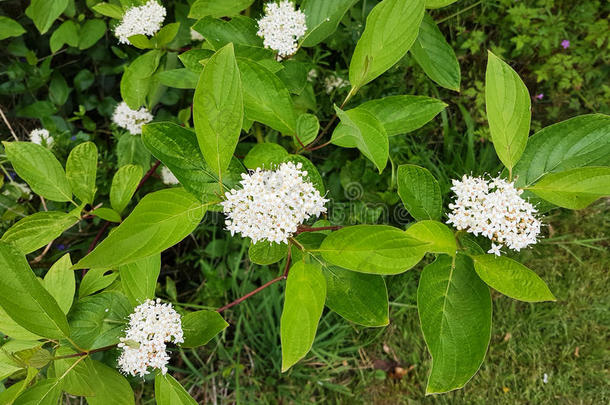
[164,201,610,404]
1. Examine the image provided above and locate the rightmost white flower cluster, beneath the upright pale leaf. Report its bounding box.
[447,175,540,256]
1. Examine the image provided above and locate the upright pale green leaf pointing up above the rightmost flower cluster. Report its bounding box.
[485,52,531,169]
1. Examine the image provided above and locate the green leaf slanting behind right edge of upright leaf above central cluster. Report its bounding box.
[237,58,296,135]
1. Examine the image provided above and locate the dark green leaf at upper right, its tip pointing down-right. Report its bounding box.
[411,13,461,91]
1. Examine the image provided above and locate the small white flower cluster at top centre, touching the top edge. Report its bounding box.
[257,0,307,58]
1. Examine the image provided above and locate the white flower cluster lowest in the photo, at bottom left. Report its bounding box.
[118,299,184,377]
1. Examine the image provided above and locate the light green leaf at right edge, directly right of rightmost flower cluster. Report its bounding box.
[528,166,610,210]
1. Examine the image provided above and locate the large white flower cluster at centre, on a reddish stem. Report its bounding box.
[220,162,328,243]
